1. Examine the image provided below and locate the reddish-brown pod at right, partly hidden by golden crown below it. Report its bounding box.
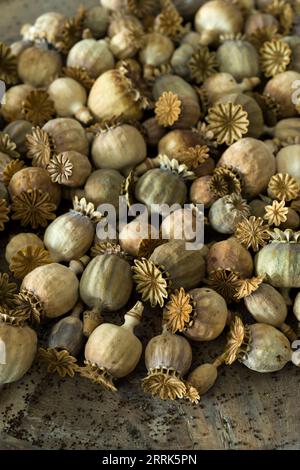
[207,237,253,278]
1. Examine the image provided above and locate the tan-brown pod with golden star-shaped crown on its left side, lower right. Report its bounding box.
[164,287,229,341]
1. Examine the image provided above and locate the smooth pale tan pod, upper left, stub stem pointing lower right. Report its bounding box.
[48,77,93,124]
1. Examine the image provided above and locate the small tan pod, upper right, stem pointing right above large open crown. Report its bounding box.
[203,72,260,105]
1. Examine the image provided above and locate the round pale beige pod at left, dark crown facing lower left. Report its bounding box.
[20,263,79,318]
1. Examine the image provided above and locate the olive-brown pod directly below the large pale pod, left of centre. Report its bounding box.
[84,169,124,211]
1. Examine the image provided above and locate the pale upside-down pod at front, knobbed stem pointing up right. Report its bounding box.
[79,302,144,391]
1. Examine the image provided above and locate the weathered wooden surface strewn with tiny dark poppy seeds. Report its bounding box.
[0,0,300,450]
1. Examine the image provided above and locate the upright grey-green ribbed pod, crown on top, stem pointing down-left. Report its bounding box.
[80,242,133,336]
